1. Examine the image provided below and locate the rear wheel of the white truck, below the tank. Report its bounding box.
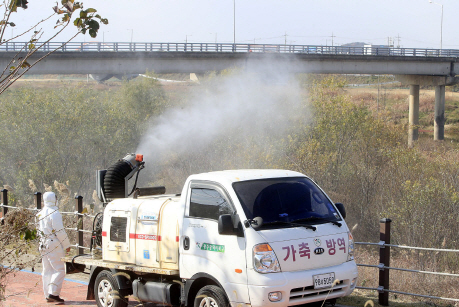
[94,271,128,307]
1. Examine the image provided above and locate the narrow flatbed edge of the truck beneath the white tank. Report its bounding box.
[61,255,179,275]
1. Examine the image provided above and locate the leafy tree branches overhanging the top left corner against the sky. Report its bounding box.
[0,0,108,94]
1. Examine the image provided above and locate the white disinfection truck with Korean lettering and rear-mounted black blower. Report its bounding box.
[63,154,357,307]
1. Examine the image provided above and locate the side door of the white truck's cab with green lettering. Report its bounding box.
[180,182,248,302]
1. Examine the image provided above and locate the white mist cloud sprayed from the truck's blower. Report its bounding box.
[136,59,310,180]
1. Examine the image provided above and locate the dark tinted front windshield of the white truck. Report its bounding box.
[233,177,341,224]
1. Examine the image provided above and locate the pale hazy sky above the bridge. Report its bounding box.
[6,0,459,49]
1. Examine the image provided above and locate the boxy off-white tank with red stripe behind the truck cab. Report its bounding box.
[102,195,183,270]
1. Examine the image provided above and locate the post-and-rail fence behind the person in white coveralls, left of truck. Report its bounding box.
[0,189,94,255]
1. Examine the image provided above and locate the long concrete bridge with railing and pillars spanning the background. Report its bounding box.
[0,42,459,146]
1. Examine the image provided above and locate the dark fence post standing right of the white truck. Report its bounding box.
[378,219,392,306]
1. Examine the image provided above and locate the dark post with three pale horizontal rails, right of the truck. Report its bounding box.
[355,219,459,306]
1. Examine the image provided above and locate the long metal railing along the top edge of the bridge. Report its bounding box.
[0,42,459,57]
